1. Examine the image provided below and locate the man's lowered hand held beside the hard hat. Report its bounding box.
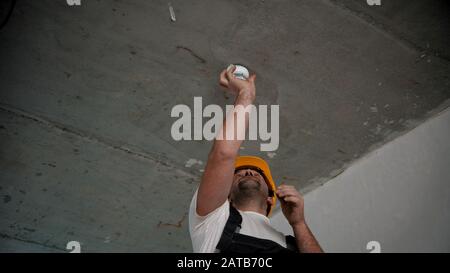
[276,185,305,226]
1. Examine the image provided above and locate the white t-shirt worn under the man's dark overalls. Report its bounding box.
[189,190,286,253]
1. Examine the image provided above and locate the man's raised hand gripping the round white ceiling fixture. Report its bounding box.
[219,66,256,99]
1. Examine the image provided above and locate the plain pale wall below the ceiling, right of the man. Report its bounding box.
[272,109,450,252]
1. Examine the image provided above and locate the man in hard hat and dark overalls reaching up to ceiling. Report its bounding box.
[189,67,322,253]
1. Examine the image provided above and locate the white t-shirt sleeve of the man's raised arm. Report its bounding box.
[189,189,230,253]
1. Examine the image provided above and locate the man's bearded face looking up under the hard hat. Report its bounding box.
[231,169,269,197]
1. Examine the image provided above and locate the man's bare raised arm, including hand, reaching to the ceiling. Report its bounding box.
[196,65,256,216]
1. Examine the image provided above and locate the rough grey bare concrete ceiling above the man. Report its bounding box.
[0,0,450,252]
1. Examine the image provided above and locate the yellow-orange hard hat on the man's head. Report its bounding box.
[234,156,277,216]
